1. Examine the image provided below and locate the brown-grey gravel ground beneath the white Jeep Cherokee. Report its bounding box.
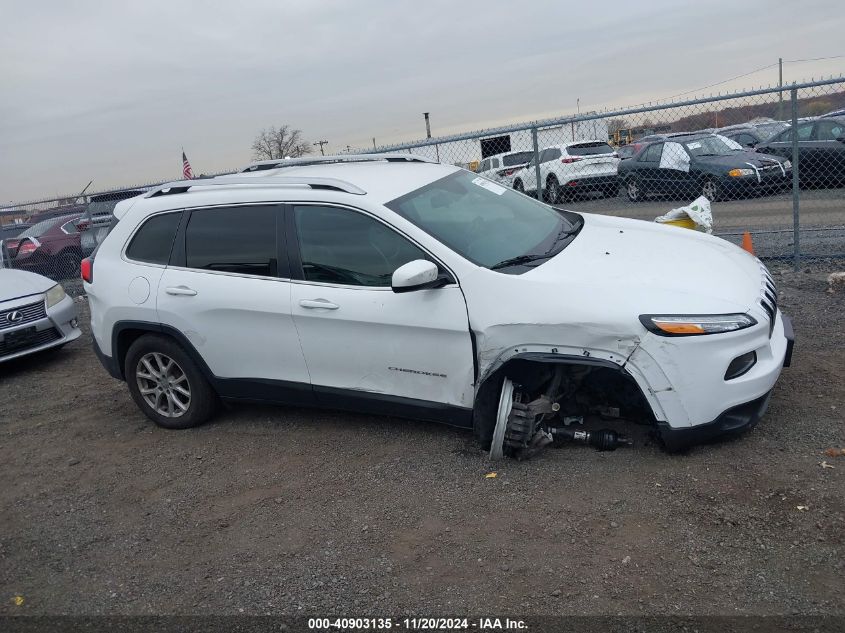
[0,271,845,616]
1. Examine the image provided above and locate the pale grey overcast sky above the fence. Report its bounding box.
[0,0,845,204]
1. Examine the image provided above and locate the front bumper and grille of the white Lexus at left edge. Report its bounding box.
[0,296,82,363]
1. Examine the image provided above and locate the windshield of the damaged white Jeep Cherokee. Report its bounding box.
[385,170,583,272]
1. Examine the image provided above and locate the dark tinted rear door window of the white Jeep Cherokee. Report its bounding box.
[185,206,279,277]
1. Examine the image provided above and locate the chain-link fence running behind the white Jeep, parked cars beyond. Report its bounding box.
[0,77,845,294]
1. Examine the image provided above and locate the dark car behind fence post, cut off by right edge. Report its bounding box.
[757,117,845,187]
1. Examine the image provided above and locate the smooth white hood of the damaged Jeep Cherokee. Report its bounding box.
[464,214,762,340]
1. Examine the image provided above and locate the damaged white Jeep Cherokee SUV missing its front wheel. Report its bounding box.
[82,154,792,456]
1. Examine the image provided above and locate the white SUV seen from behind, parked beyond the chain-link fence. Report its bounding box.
[513,140,619,204]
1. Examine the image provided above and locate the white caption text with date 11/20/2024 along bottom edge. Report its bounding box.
[308,618,528,631]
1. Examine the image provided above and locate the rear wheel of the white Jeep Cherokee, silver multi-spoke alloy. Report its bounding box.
[124,334,217,429]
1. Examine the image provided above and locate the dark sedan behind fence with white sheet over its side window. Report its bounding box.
[619,134,792,202]
